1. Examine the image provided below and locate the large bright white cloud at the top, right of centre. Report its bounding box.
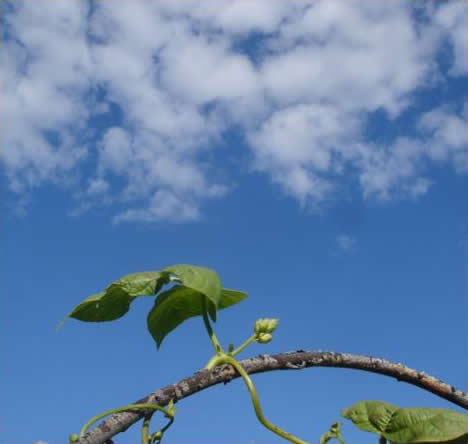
[262,0,431,115]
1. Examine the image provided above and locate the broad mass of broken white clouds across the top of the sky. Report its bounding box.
[1,0,467,221]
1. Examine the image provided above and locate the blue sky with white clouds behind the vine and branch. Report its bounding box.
[0,0,468,444]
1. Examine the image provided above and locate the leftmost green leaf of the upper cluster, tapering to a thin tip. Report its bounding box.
[59,271,170,326]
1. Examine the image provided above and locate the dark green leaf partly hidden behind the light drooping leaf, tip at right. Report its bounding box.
[147,285,247,348]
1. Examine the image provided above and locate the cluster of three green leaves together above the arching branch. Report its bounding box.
[59,264,247,348]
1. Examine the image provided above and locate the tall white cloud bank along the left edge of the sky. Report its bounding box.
[1,1,90,191]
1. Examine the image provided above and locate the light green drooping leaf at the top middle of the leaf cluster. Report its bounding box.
[164,264,221,321]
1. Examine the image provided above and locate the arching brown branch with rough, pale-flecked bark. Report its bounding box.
[79,350,468,444]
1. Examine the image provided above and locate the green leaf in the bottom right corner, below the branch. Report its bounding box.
[342,401,468,444]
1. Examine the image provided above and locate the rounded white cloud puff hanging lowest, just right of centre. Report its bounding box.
[248,104,358,204]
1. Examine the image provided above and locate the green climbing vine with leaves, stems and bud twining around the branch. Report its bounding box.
[59,264,468,444]
